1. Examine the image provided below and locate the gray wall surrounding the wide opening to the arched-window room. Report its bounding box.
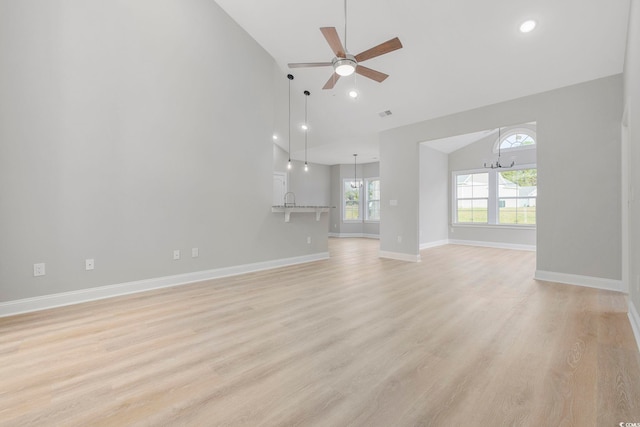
[380,75,622,280]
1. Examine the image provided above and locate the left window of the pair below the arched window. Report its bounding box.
[455,172,489,224]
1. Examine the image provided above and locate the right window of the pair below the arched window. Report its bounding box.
[498,169,538,224]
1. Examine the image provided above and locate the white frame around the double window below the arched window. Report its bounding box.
[449,164,538,230]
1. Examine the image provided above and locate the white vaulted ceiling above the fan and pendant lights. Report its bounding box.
[216,0,629,164]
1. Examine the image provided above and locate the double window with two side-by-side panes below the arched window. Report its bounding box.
[453,165,538,226]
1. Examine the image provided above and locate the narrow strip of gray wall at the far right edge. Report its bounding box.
[624,0,640,318]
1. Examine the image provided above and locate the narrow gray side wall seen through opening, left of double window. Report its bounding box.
[420,145,449,245]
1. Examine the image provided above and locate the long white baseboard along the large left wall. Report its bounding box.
[0,252,329,317]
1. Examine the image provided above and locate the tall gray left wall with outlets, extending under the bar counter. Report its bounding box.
[0,0,328,301]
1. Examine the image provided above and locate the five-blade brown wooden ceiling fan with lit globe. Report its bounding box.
[289,0,402,89]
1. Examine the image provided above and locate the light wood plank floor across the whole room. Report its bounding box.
[0,239,640,427]
